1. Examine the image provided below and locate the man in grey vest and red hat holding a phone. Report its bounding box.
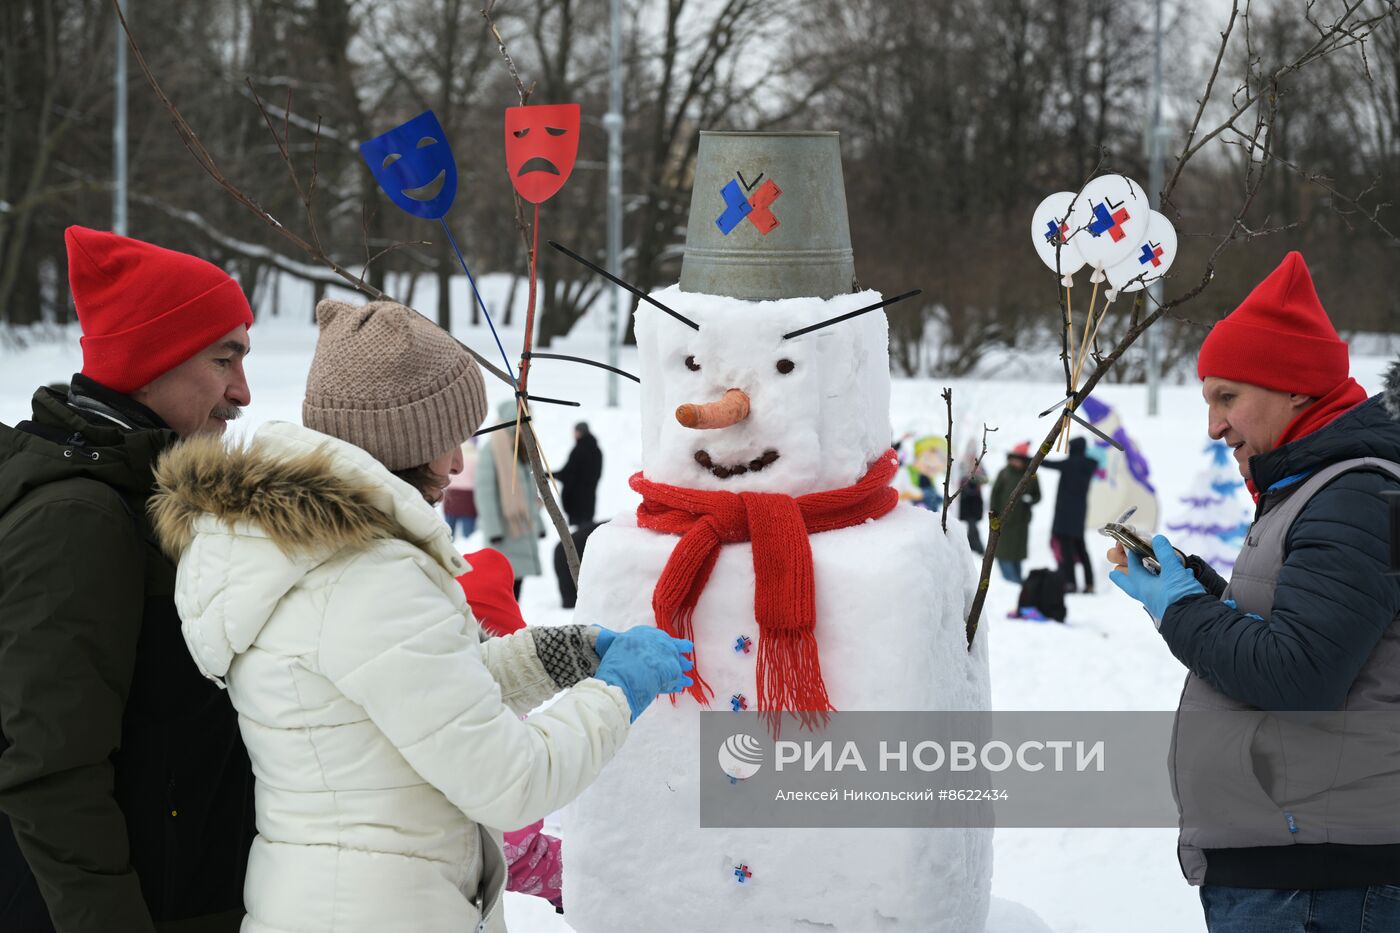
[1109,252,1400,933]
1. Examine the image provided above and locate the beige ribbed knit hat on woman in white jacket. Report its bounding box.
[301,298,486,469]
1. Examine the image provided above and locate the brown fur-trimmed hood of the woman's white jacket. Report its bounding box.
[148,422,469,677]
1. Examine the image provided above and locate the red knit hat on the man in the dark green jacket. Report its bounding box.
[63,227,253,394]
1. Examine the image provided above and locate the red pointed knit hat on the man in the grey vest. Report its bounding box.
[1196,252,1351,398]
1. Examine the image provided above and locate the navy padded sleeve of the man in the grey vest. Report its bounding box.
[1161,472,1400,710]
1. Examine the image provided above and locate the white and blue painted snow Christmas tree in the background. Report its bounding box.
[1166,441,1254,576]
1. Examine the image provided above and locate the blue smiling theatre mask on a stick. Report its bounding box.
[360,111,456,220]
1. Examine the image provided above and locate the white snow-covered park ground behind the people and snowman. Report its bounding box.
[0,276,1387,933]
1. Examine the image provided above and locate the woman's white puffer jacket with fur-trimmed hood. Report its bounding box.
[151,423,630,933]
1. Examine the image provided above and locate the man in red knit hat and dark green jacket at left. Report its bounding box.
[0,227,253,933]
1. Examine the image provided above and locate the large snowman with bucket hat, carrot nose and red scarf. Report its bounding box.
[564,133,991,933]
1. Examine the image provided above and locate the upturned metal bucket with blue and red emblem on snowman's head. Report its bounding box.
[680,130,860,300]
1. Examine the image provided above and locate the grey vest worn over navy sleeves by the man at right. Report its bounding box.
[1170,457,1400,884]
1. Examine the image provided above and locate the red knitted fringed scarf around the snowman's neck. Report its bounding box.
[630,451,899,713]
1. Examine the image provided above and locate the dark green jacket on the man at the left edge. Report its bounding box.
[0,380,253,933]
